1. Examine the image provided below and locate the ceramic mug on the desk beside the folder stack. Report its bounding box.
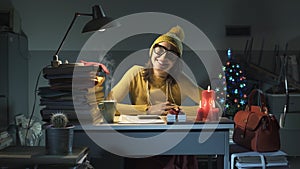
[98,100,116,123]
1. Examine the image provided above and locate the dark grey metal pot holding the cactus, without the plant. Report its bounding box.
[46,125,75,155]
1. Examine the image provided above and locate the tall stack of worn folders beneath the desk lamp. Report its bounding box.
[39,64,105,122]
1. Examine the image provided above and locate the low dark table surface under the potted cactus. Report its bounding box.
[0,146,88,168]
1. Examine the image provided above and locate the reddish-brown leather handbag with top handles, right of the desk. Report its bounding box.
[233,89,280,152]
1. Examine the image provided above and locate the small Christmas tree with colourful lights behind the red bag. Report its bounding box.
[223,49,247,117]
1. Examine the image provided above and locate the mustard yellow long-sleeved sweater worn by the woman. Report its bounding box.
[110,66,203,115]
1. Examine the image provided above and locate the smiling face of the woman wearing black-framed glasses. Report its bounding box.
[151,42,178,72]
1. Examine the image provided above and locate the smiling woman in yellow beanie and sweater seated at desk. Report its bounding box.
[109,26,202,169]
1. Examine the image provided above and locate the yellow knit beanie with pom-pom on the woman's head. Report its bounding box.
[149,25,184,57]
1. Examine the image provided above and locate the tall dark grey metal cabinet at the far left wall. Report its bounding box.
[0,32,29,131]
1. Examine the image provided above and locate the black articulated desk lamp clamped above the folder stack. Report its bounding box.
[51,5,119,67]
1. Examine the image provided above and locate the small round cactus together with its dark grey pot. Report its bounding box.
[45,113,75,155]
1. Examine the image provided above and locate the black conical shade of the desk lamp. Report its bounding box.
[82,5,119,33]
